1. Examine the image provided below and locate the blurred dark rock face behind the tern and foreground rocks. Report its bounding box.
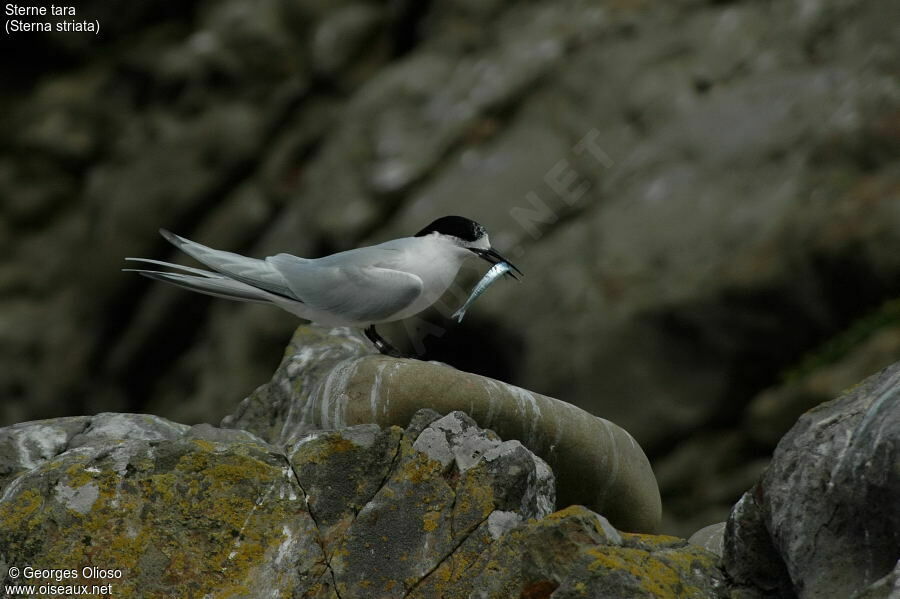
[0,0,900,534]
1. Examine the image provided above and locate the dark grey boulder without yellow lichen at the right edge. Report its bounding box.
[724,363,900,599]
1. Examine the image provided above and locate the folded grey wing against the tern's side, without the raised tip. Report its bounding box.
[266,254,422,323]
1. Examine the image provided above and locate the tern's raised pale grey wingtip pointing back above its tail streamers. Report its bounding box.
[159,229,292,299]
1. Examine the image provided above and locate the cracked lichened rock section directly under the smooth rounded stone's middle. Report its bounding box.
[302,412,554,597]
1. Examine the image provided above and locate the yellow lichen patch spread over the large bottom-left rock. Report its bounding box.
[0,442,303,598]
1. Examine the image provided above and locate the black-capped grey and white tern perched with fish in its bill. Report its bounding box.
[123,216,522,356]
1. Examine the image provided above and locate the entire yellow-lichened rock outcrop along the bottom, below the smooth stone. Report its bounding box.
[0,410,726,599]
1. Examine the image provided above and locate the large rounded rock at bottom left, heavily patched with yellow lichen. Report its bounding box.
[0,414,325,598]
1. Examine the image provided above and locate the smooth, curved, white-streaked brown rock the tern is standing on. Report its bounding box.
[223,326,660,532]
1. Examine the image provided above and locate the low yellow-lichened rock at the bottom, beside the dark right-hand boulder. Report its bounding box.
[410,506,727,599]
